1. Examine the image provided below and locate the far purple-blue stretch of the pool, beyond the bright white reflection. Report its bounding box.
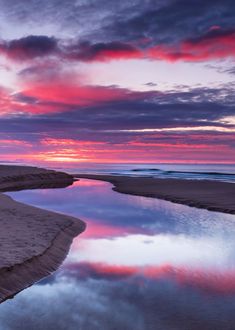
[7,179,235,240]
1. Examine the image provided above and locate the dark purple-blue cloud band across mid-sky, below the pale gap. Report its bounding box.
[0,86,235,134]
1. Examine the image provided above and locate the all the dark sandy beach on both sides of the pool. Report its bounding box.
[0,165,235,302]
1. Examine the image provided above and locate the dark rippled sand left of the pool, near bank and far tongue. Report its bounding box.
[0,166,85,302]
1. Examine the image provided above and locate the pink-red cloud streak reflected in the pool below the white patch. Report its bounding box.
[62,262,235,296]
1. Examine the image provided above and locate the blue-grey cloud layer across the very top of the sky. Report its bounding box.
[0,0,235,47]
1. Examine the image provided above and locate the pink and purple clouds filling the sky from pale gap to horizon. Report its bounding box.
[0,80,235,162]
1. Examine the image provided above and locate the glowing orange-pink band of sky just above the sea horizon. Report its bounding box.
[0,134,235,166]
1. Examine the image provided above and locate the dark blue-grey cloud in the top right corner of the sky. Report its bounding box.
[108,0,235,43]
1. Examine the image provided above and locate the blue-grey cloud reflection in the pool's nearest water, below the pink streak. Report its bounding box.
[0,277,235,330]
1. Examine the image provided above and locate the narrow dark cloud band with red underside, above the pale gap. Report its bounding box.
[0,28,235,63]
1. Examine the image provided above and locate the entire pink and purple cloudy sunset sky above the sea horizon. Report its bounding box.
[0,0,235,166]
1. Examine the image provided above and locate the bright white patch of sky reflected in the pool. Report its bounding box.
[67,234,235,269]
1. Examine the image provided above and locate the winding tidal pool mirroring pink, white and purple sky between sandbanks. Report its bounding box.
[0,180,235,330]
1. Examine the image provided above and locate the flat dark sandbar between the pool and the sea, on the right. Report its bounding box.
[74,174,235,214]
